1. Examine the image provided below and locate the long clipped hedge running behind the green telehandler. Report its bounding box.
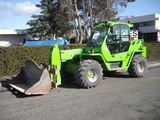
[0,43,160,76]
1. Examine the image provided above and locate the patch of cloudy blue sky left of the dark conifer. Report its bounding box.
[0,0,40,29]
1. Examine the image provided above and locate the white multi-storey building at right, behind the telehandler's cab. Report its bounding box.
[120,14,160,42]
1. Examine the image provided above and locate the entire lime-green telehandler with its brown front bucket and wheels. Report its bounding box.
[9,21,148,95]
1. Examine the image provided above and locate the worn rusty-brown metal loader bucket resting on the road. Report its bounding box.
[9,60,52,95]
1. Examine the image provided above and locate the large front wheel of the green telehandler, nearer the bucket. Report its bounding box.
[76,60,103,88]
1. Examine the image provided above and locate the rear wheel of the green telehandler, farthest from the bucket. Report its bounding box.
[128,55,148,78]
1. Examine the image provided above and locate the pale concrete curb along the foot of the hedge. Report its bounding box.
[0,63,160,87]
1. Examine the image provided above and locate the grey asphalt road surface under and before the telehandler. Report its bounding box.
[0,64,160,120]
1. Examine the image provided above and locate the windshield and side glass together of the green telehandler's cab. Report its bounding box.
[87,23,130,54]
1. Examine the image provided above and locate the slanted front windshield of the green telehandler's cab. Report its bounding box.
[87,26,107,47]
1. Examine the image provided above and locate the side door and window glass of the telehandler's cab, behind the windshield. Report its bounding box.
[106,24,130,54]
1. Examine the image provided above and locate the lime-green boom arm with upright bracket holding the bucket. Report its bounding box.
[49,45,83,85]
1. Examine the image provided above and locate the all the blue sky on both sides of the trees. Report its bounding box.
[0,0,160,29]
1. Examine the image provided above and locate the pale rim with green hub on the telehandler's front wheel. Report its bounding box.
[87,70,98,83]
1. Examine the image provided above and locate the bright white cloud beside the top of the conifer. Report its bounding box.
[13,1,39,15]
